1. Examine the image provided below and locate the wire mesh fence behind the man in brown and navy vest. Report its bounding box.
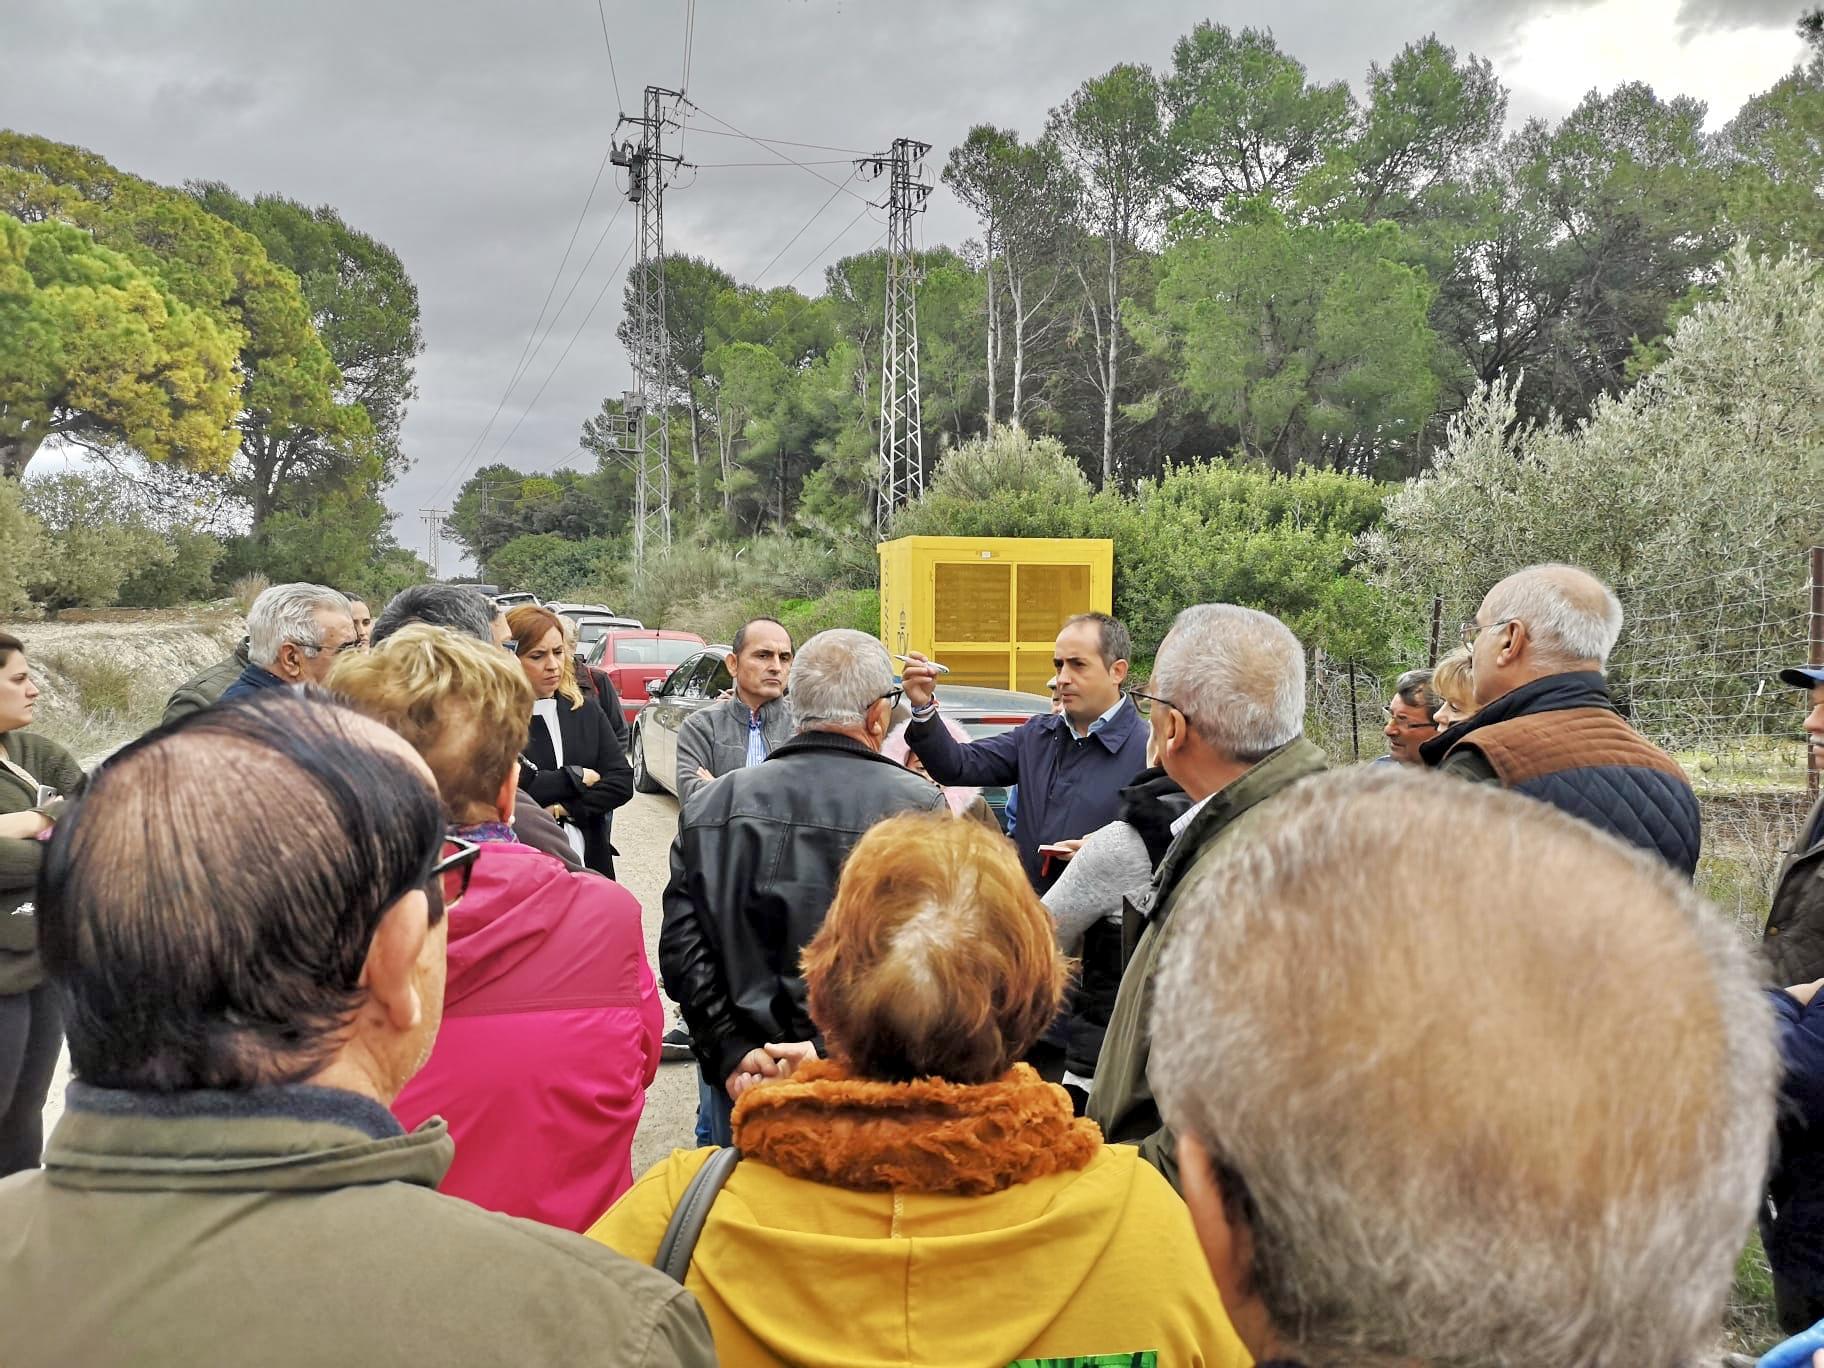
[1306,554,1824,932]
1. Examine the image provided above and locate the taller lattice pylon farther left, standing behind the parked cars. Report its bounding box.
[611,86,682,569]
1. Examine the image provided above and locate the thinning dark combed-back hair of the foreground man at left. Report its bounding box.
[38,689,443,1091]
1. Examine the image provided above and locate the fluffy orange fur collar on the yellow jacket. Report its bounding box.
[735,1060,1102,1197]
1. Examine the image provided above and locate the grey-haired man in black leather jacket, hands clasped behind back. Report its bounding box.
[658,629,943,1145]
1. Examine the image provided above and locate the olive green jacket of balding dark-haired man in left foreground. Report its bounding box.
[0,1083,715,1368]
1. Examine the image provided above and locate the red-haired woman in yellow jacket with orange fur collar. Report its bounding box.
[589,815,1248,1368]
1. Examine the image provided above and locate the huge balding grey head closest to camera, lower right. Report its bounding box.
[1153,766,1778,1368]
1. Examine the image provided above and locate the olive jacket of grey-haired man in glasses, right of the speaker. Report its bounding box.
[1089,737,1326,1187]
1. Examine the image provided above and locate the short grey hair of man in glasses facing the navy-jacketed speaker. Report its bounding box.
[1149,604,1304,761]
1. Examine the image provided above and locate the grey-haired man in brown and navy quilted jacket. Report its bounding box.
[1419,565,1704,877]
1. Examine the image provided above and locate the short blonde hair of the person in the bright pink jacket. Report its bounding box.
[328,622,533,824]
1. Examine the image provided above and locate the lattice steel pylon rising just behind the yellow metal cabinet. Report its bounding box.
[855,139,930,531]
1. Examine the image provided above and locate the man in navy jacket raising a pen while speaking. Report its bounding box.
[901,613,1147,892]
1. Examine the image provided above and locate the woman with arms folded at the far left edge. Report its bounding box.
[0,631,82,1178]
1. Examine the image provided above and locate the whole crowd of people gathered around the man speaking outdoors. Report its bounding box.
[0,565,1824,1368]
